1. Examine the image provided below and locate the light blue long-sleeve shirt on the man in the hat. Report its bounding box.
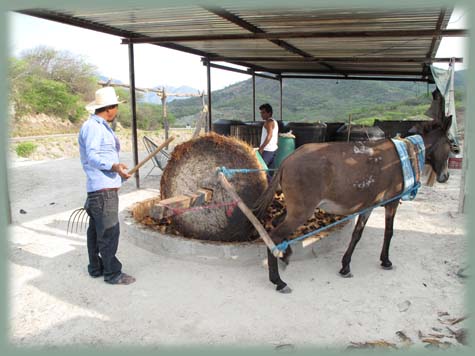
[78,115,122,192]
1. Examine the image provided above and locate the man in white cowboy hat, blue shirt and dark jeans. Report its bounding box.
[78,87,135,284]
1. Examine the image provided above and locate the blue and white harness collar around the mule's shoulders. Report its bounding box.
[391,135,425,200]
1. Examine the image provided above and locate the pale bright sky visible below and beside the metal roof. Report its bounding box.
[8,9,468,90]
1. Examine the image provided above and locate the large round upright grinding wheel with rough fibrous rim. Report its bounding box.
[160,133,267,242]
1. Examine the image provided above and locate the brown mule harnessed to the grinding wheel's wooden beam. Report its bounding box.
[254,117,452,293]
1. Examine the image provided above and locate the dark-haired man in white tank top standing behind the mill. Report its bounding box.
[259,104,279,181]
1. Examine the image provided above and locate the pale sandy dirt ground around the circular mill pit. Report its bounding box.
[8,147,468,351]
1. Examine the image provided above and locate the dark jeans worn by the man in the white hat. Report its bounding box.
[84,190,122,282]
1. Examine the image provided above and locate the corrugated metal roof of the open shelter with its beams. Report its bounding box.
[19,5,466,81]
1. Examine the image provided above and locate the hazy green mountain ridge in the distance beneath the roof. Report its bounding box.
[168,71,466,124]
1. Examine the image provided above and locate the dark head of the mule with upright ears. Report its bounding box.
[422,116,453,183]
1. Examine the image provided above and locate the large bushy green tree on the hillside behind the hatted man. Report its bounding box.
[9,47,96,122]
